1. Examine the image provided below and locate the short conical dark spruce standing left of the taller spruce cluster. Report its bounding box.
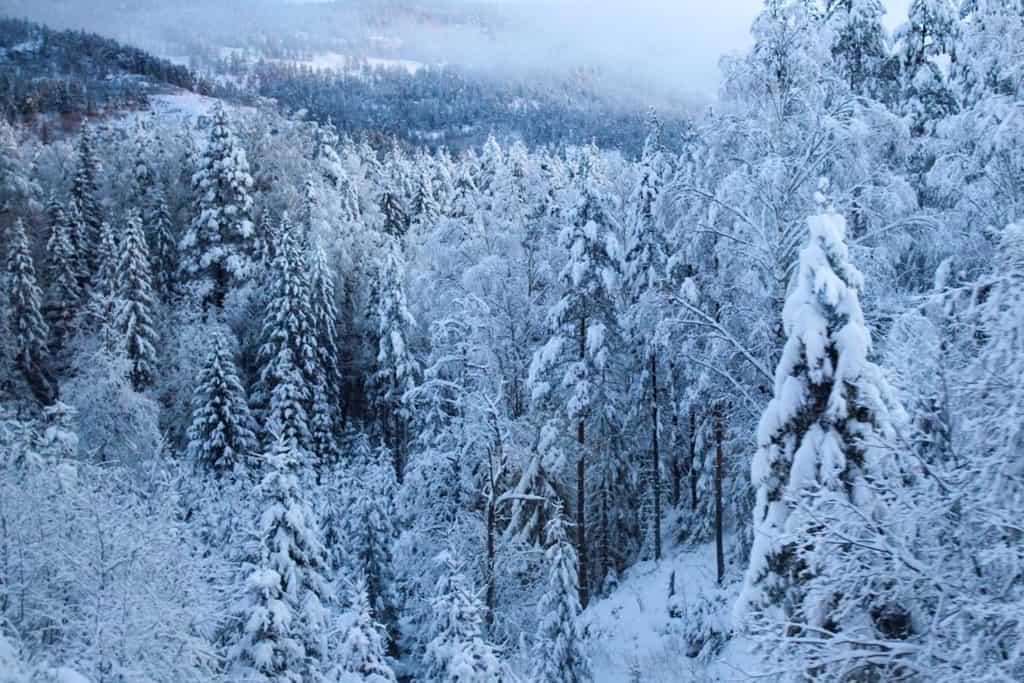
[186,334,259,477]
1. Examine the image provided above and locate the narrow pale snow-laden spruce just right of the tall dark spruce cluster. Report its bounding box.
[370,237,420,483]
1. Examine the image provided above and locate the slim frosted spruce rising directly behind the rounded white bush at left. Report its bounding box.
[115,209,158,391]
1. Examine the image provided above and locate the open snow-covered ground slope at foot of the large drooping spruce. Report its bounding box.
[581,544,755,683]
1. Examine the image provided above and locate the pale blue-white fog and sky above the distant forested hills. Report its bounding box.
[0,0,909,99]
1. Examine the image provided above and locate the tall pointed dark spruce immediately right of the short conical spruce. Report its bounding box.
[253,215,323,449]
